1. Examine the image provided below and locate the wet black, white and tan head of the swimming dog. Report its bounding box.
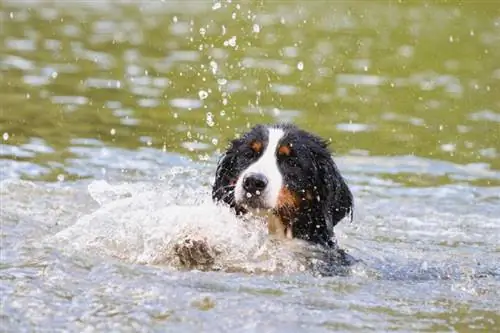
[212,125,352,242]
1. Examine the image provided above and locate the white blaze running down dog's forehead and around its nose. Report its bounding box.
[235,127,285,208]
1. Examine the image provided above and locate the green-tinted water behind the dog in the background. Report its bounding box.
[0,1,500,185]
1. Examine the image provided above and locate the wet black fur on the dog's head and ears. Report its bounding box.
[212,124,353,246]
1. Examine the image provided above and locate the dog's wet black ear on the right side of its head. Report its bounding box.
[316,147,354,229]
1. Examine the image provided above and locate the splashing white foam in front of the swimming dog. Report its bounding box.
[50,181,304,272]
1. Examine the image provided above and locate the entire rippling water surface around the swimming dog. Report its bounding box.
[0,1,500,332]
